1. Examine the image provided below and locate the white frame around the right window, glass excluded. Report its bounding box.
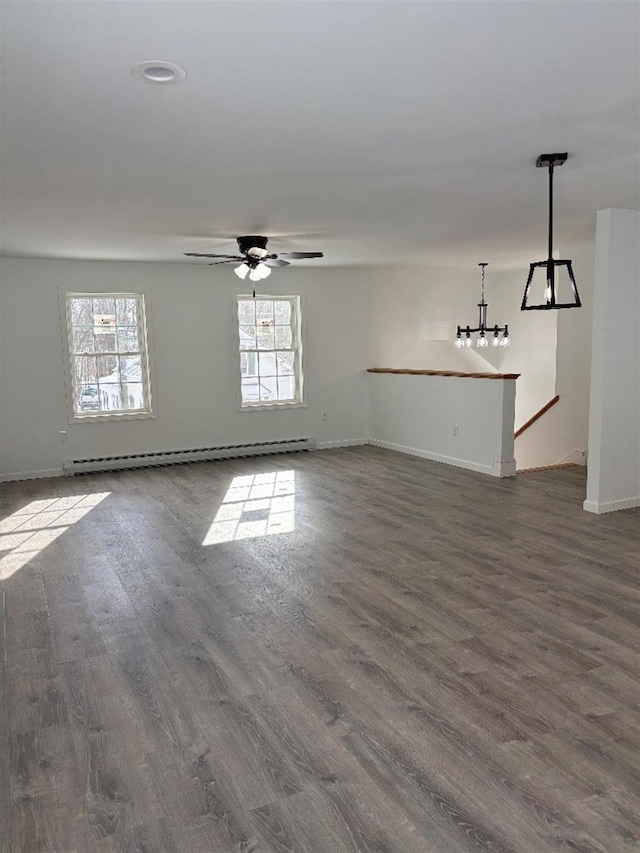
[233,292,308,412]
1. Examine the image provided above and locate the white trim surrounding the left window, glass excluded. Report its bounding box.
[58,288,157,424]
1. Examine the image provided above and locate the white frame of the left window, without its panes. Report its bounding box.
[59,289,157,424]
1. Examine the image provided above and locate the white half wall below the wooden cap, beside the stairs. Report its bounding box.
[369,373,515,477]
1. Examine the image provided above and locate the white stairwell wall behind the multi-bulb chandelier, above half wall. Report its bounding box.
[362,258,593,468]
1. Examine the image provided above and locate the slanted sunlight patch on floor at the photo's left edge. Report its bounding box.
[0,492,111,580]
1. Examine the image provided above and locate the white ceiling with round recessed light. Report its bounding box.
[2,0,639,266]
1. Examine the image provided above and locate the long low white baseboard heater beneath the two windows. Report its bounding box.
[64,438,316,477]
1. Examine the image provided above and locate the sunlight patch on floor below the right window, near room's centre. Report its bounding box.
[202,471,296,545]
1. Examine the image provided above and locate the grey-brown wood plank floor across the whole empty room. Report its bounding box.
[0,448,640,853]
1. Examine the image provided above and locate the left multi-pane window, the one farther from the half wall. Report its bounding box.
[66,293,151,420]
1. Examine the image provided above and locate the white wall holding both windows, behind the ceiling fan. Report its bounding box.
[0,258,370,476]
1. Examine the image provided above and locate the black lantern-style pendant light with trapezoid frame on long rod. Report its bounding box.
[520,153,582,311]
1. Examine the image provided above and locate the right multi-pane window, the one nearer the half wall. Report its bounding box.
[238,296,303,408]
